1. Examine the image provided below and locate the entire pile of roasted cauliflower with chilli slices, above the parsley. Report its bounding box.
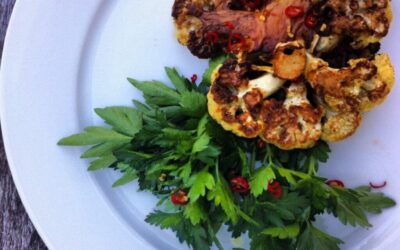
[172,0,395,150]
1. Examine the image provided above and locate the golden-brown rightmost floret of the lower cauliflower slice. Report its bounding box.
[305,55,394,112]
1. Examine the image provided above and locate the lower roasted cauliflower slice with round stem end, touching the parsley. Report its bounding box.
[208,33,394,146]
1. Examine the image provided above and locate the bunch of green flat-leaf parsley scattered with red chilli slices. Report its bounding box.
[58,57,395,250]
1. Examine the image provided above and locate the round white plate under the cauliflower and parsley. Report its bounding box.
[1,0,400,249]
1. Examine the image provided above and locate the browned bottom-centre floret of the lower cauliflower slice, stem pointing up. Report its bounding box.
[261,83,324,150]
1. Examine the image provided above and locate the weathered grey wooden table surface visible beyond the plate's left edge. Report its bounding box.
[0,0,47,250]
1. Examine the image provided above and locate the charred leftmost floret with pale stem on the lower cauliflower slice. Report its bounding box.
[207,59,284,138]
